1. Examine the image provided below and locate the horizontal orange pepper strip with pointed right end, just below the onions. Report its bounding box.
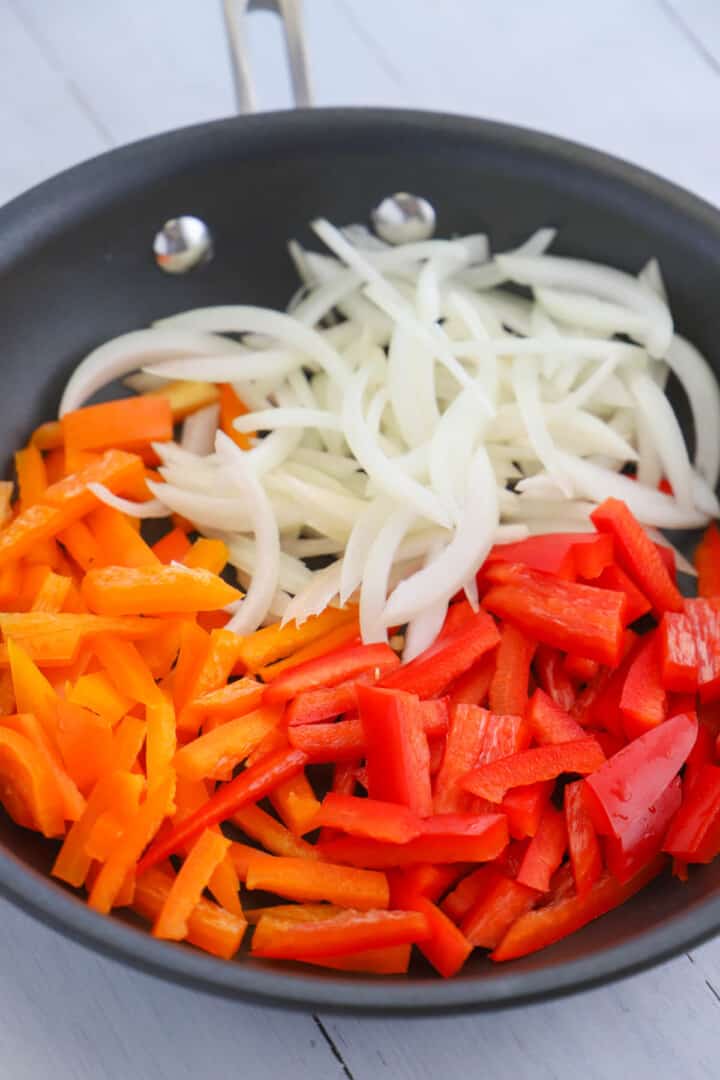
[80,565,242,616]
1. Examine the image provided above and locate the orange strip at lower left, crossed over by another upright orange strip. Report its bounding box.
[133,868,247,960]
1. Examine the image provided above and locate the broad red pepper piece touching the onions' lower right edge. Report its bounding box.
[483,563,627,665]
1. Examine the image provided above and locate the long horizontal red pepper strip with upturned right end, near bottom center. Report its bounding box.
[317,813,507,869]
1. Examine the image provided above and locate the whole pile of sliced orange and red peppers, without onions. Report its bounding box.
[0,392,720,976]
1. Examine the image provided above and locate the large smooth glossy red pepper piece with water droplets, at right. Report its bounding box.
[584,713,697,839]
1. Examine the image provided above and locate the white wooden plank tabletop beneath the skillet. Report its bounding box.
[0,0,720,1080]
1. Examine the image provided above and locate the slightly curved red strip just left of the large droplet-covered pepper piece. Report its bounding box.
[462,737,604,802]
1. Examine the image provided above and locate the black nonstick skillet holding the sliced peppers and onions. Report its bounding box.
[0,2,720,1014]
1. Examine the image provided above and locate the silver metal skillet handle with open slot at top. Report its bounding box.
[222,0,312,112]
